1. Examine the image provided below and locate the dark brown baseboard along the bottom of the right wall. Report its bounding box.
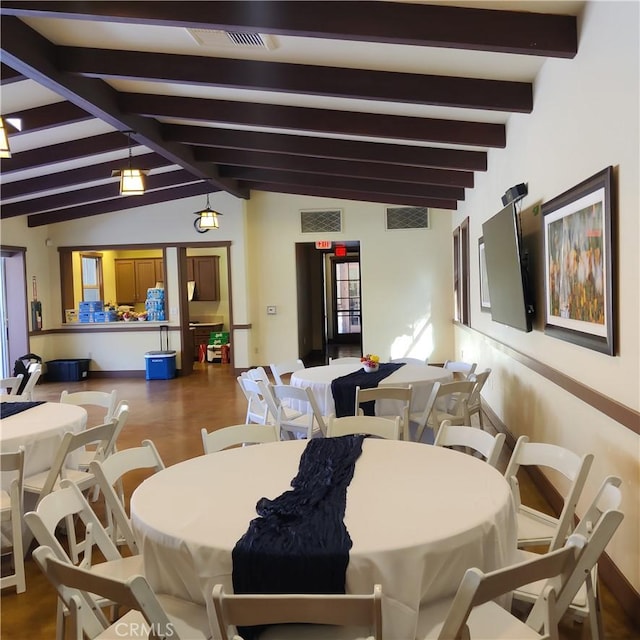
[482,402,640,627]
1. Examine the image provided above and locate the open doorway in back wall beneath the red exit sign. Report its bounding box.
[296,241,362,364]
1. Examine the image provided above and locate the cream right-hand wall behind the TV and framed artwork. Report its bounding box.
[454,2,640,590]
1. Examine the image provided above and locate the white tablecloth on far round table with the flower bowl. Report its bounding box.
[291,363,453,416]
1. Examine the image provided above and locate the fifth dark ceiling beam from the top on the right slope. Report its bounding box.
[209,149,474,187]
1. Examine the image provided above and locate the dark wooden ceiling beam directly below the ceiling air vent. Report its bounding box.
[57,47,533,113]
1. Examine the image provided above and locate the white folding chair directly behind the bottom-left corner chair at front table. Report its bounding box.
[24,480,143,640]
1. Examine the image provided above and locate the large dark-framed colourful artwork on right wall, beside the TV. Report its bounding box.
[542,167,615,356]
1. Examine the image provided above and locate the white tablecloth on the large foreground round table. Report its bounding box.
[131,439,516,640]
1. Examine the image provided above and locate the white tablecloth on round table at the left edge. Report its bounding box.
[0,402,87,491]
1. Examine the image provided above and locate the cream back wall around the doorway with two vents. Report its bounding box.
[248,192,453,364]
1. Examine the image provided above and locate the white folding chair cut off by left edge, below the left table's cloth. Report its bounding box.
[0,447,27,593]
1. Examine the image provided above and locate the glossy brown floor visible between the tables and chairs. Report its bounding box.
[0,362,640,640]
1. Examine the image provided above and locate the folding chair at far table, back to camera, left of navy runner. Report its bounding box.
[270,384,327,438]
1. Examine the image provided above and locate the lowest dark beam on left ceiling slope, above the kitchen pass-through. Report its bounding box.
[27,181,210,227]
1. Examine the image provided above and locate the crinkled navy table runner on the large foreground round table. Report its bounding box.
[232,435,365,640]
